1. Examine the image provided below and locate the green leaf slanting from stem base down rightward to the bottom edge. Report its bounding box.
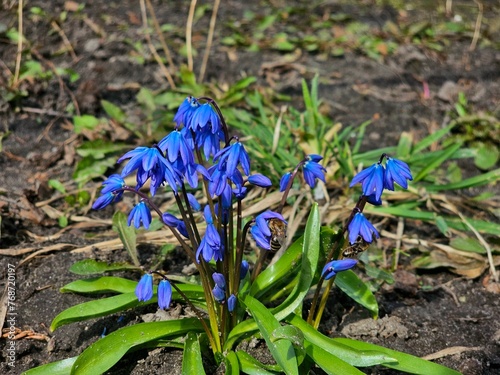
[242,295,299,375]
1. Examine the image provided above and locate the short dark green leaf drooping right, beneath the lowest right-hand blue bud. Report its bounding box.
[335,270,378,318]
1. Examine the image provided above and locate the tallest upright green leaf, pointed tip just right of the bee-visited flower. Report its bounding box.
[273,203,321,320]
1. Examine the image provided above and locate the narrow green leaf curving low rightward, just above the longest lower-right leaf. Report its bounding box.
[286,314,396,367]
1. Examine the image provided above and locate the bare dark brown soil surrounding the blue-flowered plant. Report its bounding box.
[0,0,500,375]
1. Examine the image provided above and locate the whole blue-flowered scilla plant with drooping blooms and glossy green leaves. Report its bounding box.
[29,97,455,375]
